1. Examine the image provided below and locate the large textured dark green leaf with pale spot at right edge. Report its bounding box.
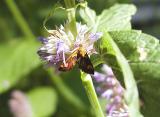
[107,30,160,117]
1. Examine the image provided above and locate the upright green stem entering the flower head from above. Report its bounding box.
[64,0,77,38]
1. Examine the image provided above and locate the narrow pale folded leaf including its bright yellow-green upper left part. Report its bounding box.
[97,32,141,117]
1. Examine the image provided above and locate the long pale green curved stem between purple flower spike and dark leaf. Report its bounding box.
[104,32,141,117]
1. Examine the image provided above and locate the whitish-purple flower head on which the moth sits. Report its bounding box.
[38,23,102,69]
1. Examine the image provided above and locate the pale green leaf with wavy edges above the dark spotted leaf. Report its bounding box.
[80,4,136,31]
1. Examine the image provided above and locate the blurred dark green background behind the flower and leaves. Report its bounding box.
[0,0,160,117]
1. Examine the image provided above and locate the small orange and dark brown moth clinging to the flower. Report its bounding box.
[59,46,94,74]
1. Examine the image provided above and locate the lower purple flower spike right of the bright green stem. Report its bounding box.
[93,65,129,117]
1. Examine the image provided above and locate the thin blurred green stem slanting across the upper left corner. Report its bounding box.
[5,0,34,39]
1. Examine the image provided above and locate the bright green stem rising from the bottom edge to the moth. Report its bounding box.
[81,72,104,117]
